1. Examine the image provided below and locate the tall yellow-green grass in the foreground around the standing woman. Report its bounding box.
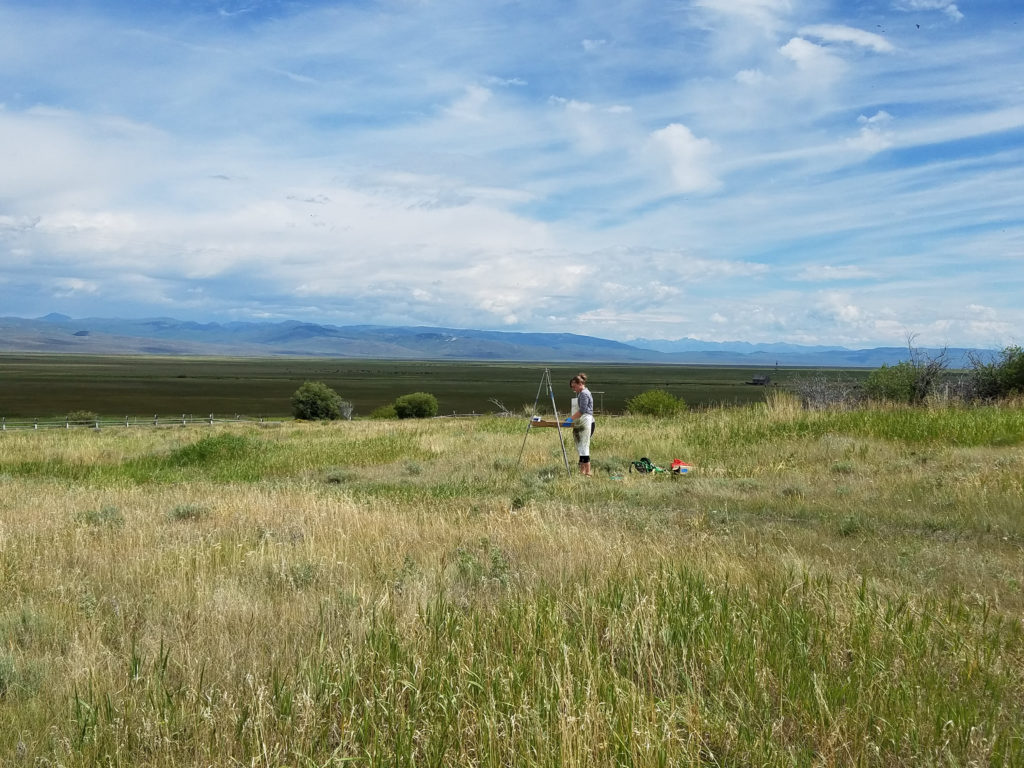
[0,399,1024,766]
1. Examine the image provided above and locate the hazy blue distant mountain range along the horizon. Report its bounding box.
[0,313,990,368]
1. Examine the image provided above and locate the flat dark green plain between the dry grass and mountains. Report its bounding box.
[0,355,866,418]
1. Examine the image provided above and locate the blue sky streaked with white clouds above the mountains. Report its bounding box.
[0,0,1024,348]
